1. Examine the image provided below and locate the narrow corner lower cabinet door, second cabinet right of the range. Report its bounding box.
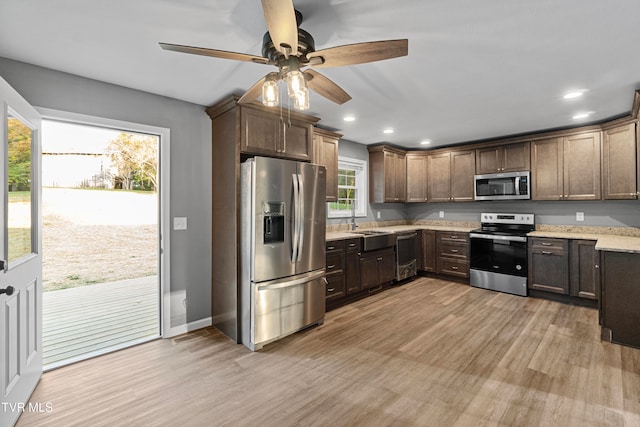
[569,240,600,300]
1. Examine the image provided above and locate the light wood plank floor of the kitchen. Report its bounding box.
[17,278,640,427]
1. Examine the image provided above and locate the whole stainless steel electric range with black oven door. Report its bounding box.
[469,213,535,296]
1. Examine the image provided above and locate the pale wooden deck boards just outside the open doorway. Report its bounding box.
[42,276,160,369]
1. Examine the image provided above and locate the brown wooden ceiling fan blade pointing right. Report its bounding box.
[307,39,409,68]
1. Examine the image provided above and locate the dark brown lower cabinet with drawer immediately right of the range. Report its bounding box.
[528,237,569,295]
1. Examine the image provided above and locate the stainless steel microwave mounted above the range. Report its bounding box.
[474,171,531,200]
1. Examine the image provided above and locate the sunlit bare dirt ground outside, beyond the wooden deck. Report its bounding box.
[42,187,158,292]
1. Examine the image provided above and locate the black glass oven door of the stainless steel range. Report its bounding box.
[470,233,528,277]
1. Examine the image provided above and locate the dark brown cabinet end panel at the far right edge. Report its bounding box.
[600,252,640,347]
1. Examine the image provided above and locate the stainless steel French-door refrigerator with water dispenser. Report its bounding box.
[240,157,327,351]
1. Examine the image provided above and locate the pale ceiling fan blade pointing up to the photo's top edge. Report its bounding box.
[262,0,298,56]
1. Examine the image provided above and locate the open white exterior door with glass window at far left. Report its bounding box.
[0,77,42,427]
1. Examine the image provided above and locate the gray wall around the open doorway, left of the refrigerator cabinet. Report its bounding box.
[0,58,211,327]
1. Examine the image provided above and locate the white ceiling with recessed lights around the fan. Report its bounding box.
[0,0,640,148]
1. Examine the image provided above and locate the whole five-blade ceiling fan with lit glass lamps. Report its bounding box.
[160,0,409,110]
